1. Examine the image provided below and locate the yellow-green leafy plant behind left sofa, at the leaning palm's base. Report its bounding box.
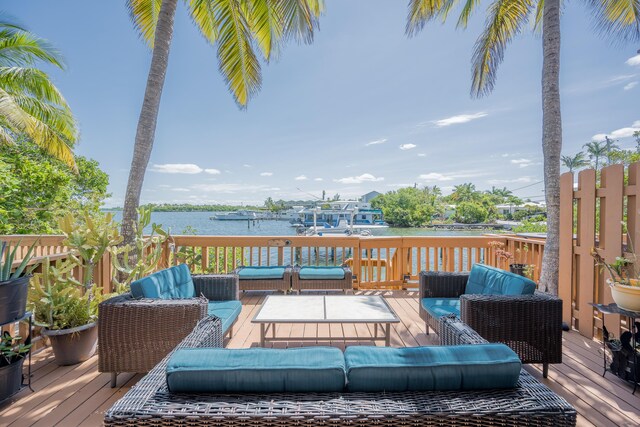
[109,206,170,293]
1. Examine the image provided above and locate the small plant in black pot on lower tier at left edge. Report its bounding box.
[0,331,31,401]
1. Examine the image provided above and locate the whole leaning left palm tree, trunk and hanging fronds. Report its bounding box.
[122,0,324,243]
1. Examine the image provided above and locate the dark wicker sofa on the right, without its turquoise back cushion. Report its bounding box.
[419,271,562,378]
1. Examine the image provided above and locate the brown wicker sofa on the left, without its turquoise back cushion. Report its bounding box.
[98,275,239,387]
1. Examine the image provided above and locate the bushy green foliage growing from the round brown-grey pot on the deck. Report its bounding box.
[29,256,104,330]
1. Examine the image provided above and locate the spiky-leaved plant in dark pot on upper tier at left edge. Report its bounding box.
[0,242,37,325]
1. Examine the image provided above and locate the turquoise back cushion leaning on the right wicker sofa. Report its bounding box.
[464,264,536,295]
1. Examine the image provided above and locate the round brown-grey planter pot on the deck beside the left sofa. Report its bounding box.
[41,323,98,366]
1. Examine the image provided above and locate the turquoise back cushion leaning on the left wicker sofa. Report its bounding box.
[131,264,196,299]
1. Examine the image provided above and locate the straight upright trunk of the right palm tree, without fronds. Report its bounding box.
[540,0,562,294]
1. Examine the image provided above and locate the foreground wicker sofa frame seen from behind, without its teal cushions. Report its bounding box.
[104,318,576,427]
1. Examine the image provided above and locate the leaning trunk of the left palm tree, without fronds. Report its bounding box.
[122,0,178,244]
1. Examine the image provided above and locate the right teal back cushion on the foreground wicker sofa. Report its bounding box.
[344,344,522,393]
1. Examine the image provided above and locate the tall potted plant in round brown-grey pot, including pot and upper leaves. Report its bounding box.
[29,211,122,365]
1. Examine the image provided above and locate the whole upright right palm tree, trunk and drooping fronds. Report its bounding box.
[407,0,640,293]
